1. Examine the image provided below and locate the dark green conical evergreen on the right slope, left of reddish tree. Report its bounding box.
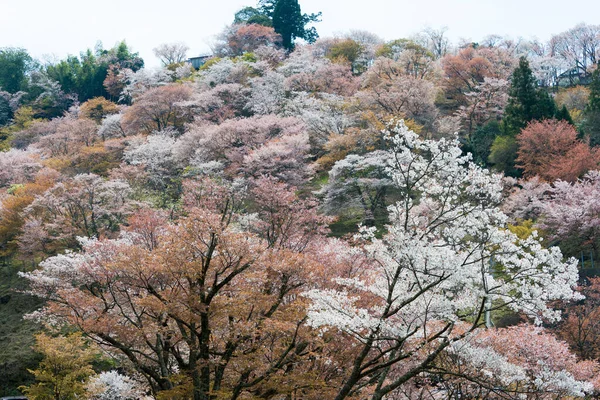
[502,57,557,136]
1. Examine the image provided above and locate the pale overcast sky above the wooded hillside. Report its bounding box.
[0,0,600,66]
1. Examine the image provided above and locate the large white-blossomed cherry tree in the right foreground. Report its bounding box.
[305,122,578,400]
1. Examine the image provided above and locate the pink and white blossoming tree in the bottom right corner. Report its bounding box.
[437,325,600,399]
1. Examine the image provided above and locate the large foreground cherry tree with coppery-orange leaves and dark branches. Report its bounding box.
[23,180,330,400]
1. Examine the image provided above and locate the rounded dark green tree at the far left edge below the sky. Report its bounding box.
[0,47,35,93]
